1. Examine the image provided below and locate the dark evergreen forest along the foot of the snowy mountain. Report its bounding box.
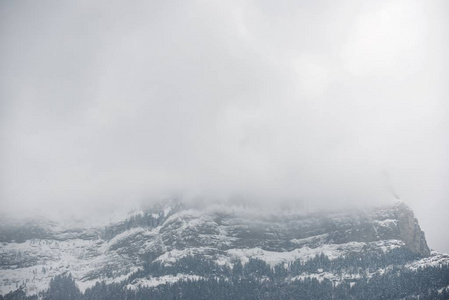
[0,251,449,300]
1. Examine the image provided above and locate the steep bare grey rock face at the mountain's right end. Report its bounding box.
[395,203,430,256]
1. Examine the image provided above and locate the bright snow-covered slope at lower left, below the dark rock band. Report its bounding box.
[0,239,138,295]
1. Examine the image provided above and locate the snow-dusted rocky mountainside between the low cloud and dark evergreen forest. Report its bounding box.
[0,203,438,294]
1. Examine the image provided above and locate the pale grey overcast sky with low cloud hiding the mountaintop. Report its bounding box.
[0,0,449,251]
